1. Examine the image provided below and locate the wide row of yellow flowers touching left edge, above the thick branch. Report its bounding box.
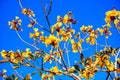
[0,48,32,64]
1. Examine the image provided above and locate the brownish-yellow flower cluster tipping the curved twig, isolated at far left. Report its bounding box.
[8,16,22,31]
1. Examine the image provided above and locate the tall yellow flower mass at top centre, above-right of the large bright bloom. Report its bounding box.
[51,12,75,41]
